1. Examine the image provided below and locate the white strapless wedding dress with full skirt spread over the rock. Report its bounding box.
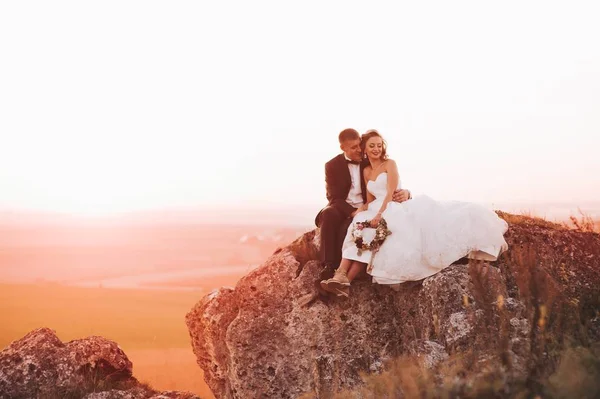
[342,172,508,284]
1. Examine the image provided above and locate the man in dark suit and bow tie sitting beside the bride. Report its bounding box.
[315,129,410,295]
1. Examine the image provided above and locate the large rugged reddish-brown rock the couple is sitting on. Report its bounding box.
[186,213,600,398]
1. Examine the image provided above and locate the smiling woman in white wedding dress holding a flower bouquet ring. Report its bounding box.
[321,130,508,296]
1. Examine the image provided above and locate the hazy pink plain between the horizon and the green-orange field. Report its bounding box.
[0,224,302,284]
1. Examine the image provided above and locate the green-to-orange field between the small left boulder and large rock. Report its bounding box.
[0,282,246,398]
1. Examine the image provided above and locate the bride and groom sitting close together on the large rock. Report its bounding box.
[315,129,508,297]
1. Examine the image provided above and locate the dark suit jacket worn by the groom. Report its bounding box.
[315,153,368,226]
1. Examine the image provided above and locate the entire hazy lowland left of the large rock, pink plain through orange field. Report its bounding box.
[0,220,310,398]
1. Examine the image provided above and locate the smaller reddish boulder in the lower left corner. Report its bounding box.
[0,328,202,399]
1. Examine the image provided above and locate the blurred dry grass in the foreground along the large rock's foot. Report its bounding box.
[322,347,600,399]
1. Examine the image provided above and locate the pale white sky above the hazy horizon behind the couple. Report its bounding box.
[0,0,600,214]
